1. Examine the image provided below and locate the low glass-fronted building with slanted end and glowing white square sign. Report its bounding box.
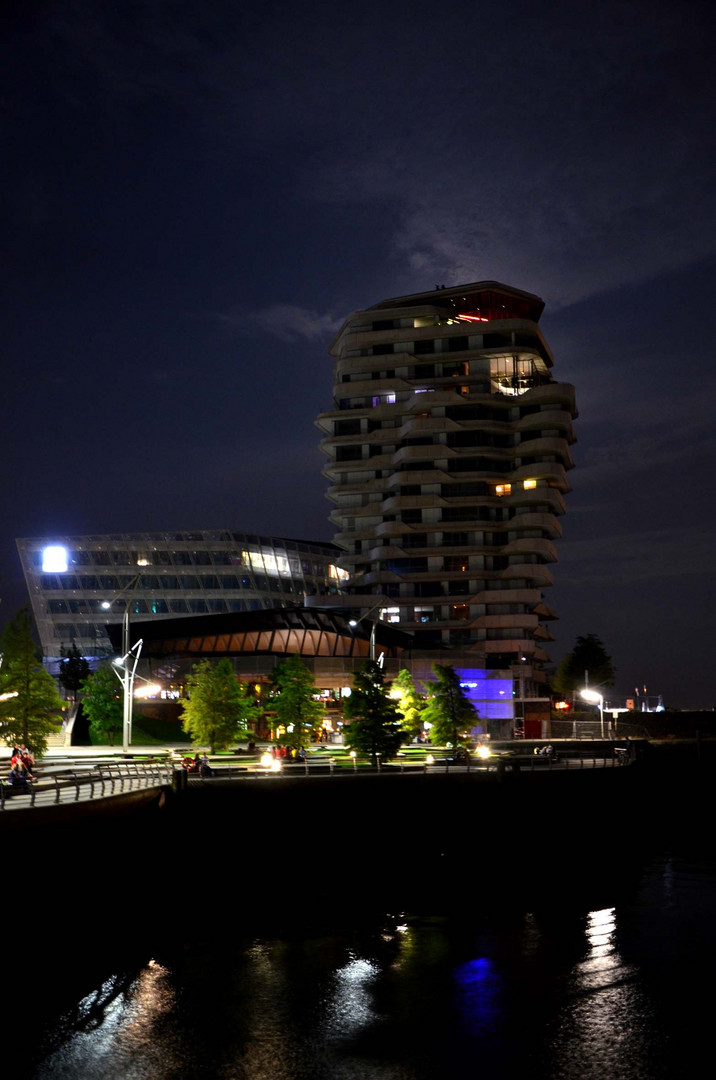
[17,530,347,659]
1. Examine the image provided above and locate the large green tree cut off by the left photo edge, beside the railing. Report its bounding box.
[0,608,64,757]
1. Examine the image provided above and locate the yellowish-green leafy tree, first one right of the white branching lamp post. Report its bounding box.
[181,659,256,754]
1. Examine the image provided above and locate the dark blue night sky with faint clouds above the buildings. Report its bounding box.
[0,0,716,707]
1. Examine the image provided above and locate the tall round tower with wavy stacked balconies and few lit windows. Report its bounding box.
[316,281,577,697]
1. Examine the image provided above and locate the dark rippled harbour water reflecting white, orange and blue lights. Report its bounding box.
[22,834,716,1080]
